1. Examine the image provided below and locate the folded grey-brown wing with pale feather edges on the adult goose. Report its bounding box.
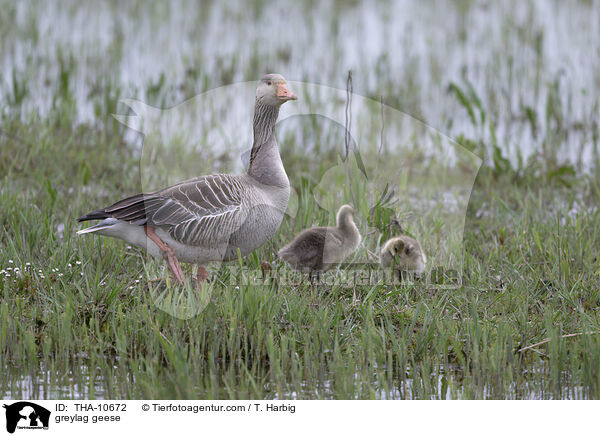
[79,174,247,246]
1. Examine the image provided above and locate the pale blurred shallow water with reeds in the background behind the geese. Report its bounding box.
[0,0,600,168]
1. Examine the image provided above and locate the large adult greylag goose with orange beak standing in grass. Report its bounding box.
[77,74,297,284]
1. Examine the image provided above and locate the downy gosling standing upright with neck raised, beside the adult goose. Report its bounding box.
[277,204,361,279]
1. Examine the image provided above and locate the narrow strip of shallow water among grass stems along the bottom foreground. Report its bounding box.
[0,365,591,400]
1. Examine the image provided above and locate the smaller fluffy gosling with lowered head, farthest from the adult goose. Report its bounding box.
[379,235,427,275]
